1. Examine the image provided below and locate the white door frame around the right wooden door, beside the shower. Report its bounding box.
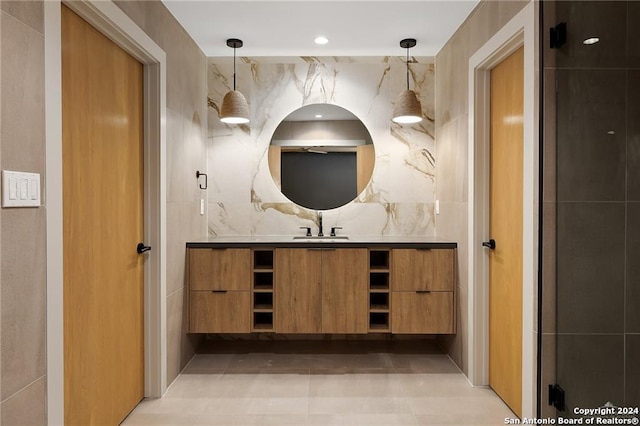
[467,1,539,418]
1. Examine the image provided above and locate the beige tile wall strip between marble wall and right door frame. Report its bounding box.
[435,0,529,374]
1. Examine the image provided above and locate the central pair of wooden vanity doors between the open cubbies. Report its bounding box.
[275,248,367,334]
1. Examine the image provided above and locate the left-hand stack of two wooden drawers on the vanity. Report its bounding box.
[188,248,251,333]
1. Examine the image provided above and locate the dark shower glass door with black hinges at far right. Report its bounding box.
[541,1,640,424]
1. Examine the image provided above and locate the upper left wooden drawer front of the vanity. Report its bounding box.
[189,248,251,290]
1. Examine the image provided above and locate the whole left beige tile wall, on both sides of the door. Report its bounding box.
[0,1,207,425]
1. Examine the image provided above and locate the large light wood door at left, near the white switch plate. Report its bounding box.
[62,7,145,425]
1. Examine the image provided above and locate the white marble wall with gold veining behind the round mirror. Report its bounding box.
[207,57,435,236]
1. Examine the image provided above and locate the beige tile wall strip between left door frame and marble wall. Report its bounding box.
[115,0,207,383]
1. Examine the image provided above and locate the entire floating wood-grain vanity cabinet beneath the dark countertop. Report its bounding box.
[187,246,455,334]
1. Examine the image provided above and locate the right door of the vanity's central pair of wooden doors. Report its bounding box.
[322,248,369,333]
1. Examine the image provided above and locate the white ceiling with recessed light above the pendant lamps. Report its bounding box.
[163,0,478,57]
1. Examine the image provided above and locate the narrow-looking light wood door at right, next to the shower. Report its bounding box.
[489,48,524,416]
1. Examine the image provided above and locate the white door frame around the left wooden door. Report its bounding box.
[44,0,167,425]
